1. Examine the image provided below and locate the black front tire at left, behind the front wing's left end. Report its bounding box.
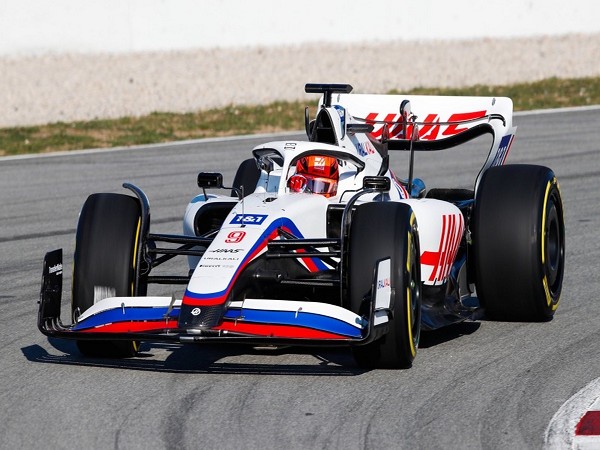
[71,193,146,357]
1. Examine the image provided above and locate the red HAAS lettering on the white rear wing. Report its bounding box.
[366,110,487,141]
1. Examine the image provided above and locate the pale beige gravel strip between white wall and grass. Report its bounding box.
[0,34,600,127]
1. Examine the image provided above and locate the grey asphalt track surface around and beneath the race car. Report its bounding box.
[0,109,600,449]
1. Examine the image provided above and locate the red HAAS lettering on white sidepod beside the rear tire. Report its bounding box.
[421,214,464,283]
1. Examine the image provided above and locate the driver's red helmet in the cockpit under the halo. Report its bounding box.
[288,155,340,197]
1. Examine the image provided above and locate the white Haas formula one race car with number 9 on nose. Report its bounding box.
[38,84,565,368]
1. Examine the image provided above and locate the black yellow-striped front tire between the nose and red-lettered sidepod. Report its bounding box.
[347,202,421,369]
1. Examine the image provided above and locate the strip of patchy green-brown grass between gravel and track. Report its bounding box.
[0,78,600,156]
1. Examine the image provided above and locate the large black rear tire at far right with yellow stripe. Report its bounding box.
[472,165,565,321]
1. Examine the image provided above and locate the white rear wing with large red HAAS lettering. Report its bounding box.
[307,85,516,190]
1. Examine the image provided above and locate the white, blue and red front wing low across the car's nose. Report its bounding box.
[38,250,389,346]
